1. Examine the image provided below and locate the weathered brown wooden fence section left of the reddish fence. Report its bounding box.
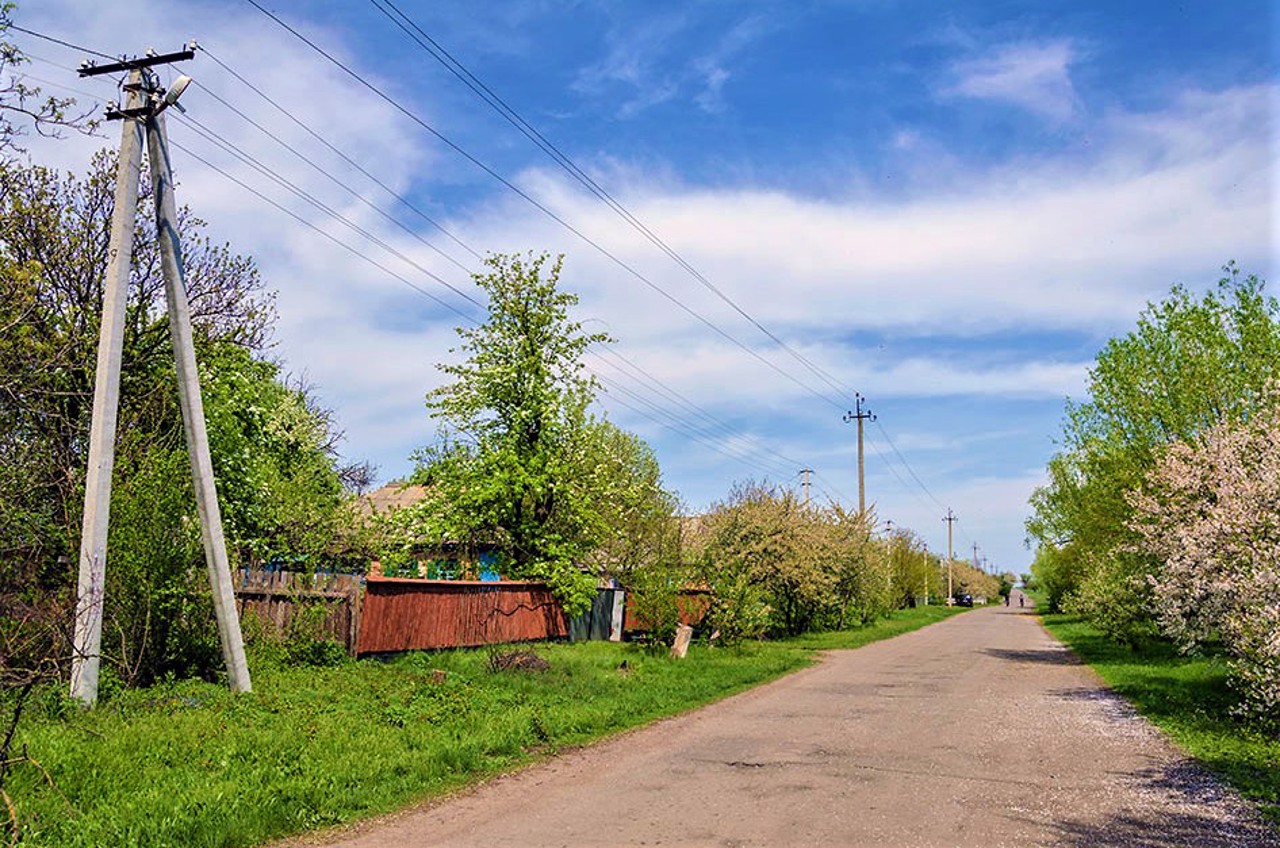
[233,569,365,653]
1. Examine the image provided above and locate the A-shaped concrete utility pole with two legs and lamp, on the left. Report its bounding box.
[70,48,252,705]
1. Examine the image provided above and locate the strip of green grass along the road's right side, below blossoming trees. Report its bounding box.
[1041,614,1280,824]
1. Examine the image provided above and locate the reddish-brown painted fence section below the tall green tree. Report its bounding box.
[356,575,568,655]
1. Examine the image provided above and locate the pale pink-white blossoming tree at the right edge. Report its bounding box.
[1129,380,1280,728]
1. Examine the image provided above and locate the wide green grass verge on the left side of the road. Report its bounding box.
[0,607,951,847]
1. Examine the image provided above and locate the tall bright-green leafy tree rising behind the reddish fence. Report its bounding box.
[408,255,609,615]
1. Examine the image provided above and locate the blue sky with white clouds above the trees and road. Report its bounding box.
[14,0,1280,571]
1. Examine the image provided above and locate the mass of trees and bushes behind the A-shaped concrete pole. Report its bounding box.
[0,154,363,684]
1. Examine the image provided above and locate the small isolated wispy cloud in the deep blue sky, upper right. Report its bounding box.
[940,40,1082,123]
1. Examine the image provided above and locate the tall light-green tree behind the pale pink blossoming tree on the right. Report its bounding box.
[1027,265,1280,644]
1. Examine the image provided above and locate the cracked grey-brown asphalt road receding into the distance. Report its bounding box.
[307,599,1280,848]
